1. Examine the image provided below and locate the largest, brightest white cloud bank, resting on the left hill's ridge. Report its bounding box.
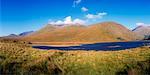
[49,16,86,25]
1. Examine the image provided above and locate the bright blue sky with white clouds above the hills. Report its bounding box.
[0,0,150,36]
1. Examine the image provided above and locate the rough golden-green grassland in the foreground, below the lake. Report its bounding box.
[0,40,150,75]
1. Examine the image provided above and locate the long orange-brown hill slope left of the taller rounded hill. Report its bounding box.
[23,26,84,42]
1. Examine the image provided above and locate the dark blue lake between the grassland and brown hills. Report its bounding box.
[32,41,150,51]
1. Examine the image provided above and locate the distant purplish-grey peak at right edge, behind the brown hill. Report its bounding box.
[132,25,150,38]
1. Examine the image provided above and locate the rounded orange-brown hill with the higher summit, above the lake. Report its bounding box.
[72,22,136,42]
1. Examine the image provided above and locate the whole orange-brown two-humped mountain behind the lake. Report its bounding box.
[22,22,137,42]
